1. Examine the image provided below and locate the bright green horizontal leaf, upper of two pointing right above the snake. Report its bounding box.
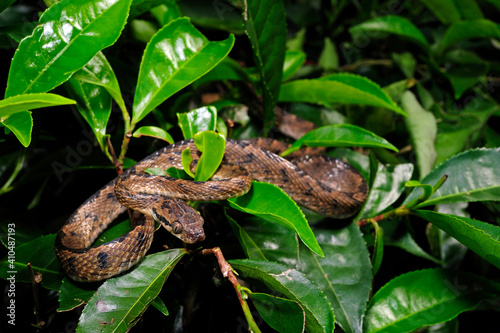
[279,73,406,115]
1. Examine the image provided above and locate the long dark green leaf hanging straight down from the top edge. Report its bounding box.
[243,0,287,132]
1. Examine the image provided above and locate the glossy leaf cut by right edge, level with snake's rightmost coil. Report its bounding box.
[404,148,500,208]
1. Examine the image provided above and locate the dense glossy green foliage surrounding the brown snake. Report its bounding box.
[0,0,500,332]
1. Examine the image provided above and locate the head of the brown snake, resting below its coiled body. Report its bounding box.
[152,198,205,244]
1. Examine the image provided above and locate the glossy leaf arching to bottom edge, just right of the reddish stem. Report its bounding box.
[229,259,335,332]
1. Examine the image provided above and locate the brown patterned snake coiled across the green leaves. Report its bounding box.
[55,139,367,281]
